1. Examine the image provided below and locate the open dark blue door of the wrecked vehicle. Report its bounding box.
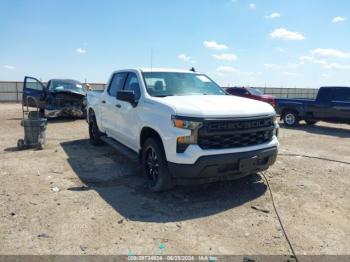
[22,76,45,109]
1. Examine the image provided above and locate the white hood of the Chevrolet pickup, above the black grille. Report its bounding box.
[155,95,275,118]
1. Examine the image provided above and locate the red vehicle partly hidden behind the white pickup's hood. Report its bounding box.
[226,87,276,107]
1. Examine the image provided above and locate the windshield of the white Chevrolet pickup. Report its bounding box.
[143,72,225,97]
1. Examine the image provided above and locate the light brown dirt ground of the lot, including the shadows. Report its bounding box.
[0,104,350,255]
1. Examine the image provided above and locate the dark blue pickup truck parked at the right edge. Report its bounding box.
[275,87,350,126]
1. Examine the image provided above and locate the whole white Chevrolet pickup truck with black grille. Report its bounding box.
[87,69,278,191]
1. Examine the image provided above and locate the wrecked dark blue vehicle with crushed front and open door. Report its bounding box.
[22,76,86,118]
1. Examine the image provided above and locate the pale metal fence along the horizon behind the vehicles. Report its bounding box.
[0,81,318,102]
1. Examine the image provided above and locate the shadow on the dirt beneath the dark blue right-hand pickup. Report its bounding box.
[280,124,350,138]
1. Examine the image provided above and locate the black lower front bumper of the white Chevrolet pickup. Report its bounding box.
[168,147,278,185]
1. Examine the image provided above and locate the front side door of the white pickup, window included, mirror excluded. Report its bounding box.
[117,72,141,151]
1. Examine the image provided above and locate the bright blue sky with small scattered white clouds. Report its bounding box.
[0,0,350,87]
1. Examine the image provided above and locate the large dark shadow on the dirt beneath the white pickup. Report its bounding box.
[61,140,266,222]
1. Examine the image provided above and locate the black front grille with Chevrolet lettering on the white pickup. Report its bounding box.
[198,117,274,149]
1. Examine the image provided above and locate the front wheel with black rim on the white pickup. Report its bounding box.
[142,137,173,192]
